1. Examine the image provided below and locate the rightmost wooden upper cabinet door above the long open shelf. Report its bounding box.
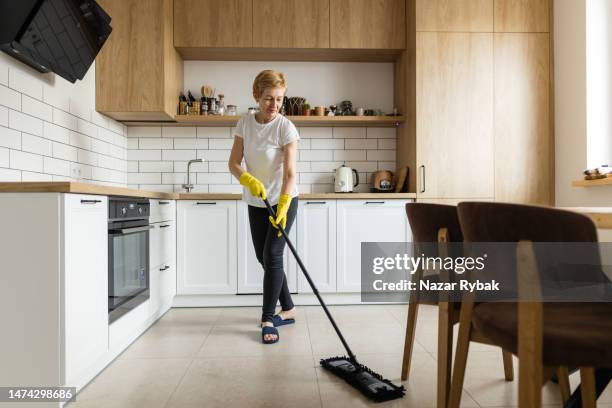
[329,0,406,49]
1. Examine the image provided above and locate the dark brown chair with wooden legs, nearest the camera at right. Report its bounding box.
[449,202,612,408]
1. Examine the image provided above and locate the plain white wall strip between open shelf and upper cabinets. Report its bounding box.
[184,61,393,113]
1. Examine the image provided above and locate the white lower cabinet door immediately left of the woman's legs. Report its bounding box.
[176,200,237,295]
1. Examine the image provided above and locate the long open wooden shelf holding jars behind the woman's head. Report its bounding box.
[174,115,404,127]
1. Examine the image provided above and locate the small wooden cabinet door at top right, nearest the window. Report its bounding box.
[495,0,550,33]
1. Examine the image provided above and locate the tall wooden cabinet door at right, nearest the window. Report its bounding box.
[494,33,554,205]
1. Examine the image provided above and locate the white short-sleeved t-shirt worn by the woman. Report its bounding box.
[234,113,300,208]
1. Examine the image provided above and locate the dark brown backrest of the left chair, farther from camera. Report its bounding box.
[406,203,463,242]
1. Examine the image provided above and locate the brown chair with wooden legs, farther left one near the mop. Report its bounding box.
[401,203,514,408]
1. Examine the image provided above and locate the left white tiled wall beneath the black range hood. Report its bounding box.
[0,52,127,186]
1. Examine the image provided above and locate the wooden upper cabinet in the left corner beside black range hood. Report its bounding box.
[96,0,183,120]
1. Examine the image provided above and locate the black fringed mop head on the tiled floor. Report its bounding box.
[321,357,405,402]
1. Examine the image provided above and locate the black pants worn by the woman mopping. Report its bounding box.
[249,197,298,322]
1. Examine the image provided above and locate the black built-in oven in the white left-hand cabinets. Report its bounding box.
[108,197,153,323]
